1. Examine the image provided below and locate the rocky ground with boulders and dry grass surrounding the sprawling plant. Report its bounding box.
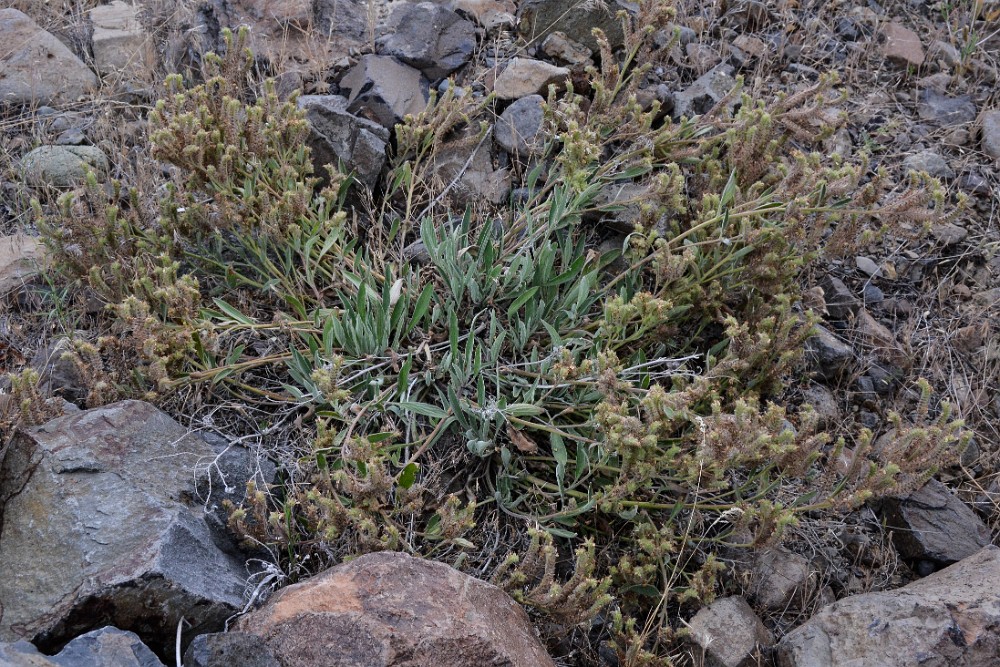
[0,0,1000,667]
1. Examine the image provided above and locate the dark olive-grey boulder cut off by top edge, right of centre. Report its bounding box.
[517,0,635,52]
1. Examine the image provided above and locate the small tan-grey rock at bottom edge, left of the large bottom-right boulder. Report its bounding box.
[688,595,774,667]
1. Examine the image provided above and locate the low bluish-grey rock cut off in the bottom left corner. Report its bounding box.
[0,627,163,667]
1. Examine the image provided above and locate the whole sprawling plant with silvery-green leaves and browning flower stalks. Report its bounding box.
[31,13,960,664]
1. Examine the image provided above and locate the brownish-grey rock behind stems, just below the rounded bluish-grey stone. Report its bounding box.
[434,130,511,208]
